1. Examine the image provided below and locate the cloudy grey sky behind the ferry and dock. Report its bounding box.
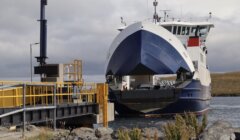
[0,0,240,78]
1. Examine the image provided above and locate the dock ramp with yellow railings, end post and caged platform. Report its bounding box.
[0,60,108,129]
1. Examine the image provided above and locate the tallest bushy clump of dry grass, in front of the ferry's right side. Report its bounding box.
[164,113,207,140]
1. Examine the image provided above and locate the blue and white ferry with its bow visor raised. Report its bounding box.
[105,0,214,116]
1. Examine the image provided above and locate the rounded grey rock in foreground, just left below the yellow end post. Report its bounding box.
[71,127,98,140]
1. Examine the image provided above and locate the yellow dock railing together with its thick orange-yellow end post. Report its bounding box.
[0,81,108,127]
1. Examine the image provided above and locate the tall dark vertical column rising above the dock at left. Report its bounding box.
[36,0,47,66]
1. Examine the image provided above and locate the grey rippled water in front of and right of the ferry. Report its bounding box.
[109,97,240,129]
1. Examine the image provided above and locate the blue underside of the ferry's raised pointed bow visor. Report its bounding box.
[106,30,190,75]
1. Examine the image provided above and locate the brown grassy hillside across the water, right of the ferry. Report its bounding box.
[211,72,240,96]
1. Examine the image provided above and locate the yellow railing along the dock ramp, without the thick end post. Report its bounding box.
[0,81,97,108]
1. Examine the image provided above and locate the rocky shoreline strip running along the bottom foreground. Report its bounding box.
[0,120,240,140]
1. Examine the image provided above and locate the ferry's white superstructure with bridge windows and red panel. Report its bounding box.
[160,21,214,86]
